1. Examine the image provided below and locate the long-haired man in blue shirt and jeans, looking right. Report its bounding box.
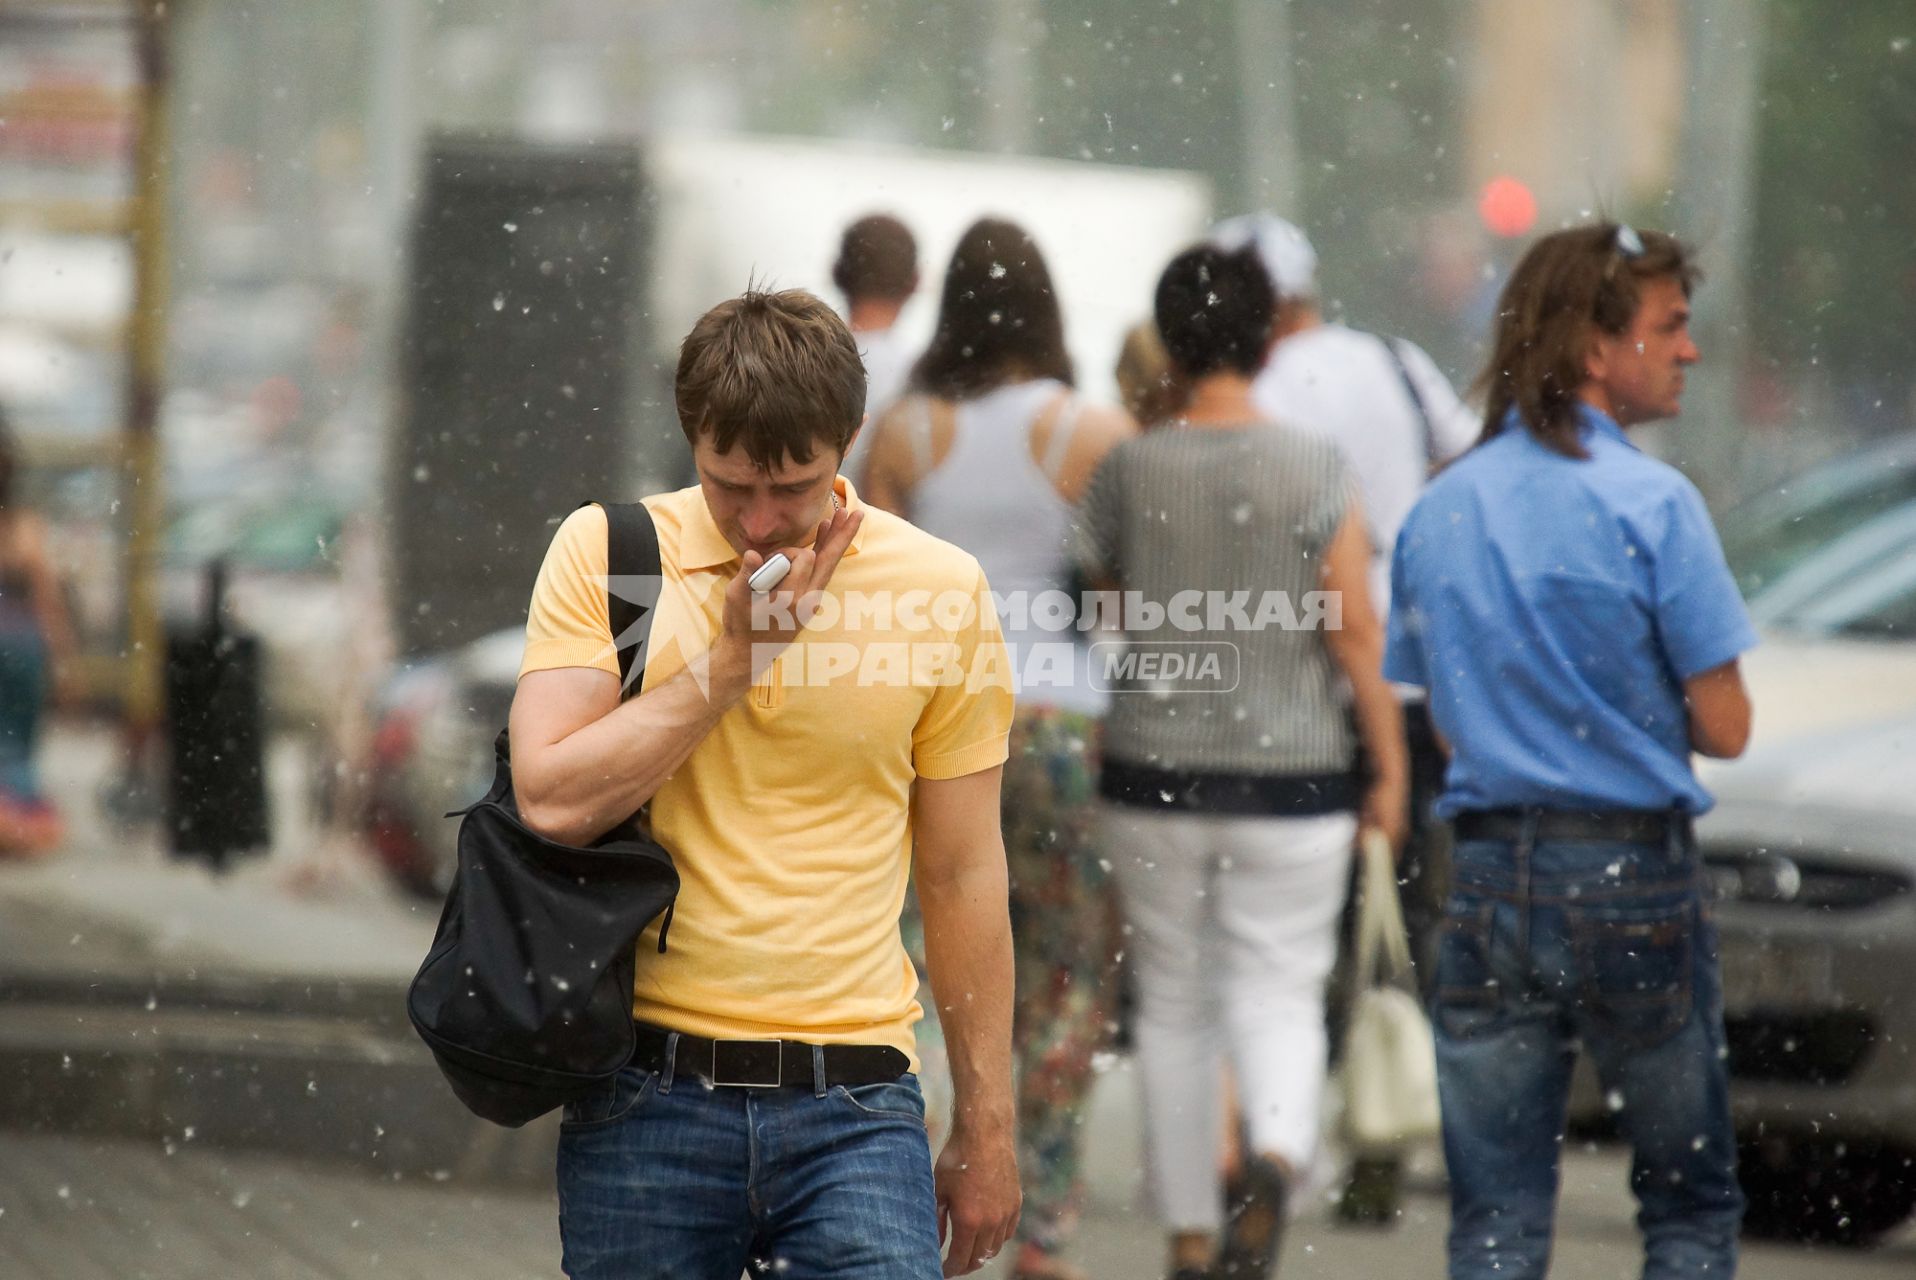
[1383,222,1755,1280]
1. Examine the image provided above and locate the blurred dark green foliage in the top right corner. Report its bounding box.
[1749,0,1916,419]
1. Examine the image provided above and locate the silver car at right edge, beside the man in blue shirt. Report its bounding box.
[1698,475,1916,1244]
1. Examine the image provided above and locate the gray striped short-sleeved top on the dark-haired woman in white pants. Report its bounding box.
[1075,423,1355,776]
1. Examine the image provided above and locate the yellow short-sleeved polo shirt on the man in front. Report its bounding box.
[519,477,1012,1065]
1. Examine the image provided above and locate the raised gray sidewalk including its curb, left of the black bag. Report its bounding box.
[0,730,556,1186]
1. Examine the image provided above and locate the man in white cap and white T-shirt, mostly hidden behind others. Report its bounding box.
[1211,213,1481,1223]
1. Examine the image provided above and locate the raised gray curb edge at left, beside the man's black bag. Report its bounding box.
[0,881,558,1188]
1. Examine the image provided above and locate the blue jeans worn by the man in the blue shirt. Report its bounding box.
[1431,823,1744,1280]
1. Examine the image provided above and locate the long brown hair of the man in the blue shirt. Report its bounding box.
[1475,222,1703,458]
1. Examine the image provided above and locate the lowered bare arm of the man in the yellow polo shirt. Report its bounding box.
[912,768,1021,1276]
